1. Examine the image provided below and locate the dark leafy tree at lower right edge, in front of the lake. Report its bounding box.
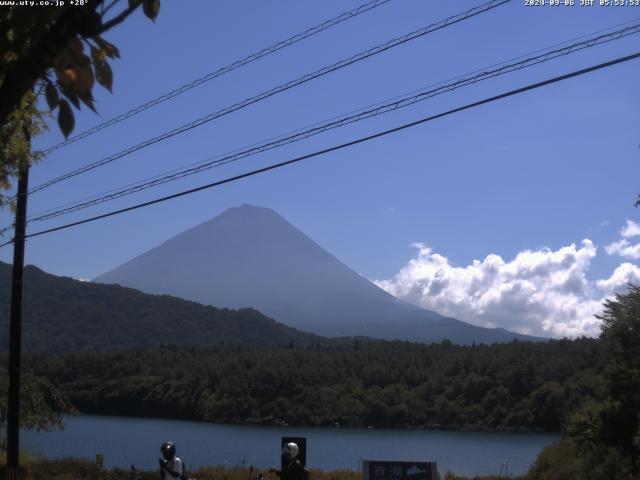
[530,286,640,480]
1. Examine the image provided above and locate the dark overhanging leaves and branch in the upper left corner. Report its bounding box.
[0,0,160,208]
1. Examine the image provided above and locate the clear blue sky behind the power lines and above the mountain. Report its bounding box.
[0,0,640,335]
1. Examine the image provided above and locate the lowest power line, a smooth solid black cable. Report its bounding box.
[0,52,640,247]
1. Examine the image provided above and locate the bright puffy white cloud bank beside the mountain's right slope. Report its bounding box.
[376,239,640,337]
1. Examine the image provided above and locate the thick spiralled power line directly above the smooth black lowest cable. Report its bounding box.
[22,23,640,222]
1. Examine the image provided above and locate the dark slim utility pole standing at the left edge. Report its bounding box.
[7,128,31,480]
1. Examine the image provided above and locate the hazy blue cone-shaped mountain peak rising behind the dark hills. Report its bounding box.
[95,205,537,344]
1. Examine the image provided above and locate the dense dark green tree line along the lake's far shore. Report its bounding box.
[28,338,603,431]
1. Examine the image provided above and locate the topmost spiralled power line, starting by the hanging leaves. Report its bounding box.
[42,0,391,155]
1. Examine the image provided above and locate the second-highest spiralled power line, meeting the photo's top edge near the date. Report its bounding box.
[29,0,511,194]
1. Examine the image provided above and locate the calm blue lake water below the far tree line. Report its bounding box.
[21,415,558,476]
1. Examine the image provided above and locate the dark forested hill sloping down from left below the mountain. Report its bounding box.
[0,262,328,353]
